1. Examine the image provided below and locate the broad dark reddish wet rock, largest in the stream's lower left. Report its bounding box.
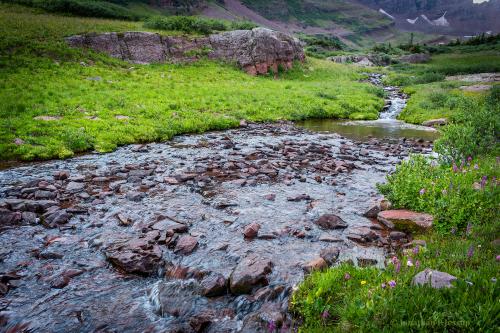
[105,238,162,275]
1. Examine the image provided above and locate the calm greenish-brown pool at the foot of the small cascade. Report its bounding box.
[297,119,439,141]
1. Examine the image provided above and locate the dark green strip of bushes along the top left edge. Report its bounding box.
[6,0,140,20]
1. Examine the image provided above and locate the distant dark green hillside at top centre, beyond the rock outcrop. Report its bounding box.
[242,0,391,33]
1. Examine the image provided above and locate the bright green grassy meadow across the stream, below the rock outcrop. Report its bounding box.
[0,5,383,160]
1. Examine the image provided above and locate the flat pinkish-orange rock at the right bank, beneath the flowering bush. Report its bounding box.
[377,209,433,231]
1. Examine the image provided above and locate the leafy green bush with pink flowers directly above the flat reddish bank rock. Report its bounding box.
[378,155,500,230]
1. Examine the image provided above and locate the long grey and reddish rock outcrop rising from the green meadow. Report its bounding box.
[66,28,305,75]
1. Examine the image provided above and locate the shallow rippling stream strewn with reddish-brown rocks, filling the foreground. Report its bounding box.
[0,123,431,332]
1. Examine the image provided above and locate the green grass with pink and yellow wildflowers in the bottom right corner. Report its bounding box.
[291,221,500,332]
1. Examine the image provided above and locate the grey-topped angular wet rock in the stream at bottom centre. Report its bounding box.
[230,255,272,295]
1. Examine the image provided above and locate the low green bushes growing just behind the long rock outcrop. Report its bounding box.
[144,16,228,35]
